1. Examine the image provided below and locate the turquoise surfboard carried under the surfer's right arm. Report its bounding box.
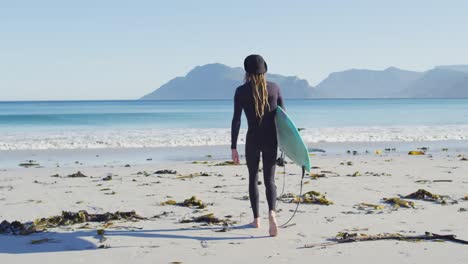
[275,106,310,172]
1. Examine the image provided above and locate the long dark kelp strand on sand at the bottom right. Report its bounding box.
[304,232,468,248]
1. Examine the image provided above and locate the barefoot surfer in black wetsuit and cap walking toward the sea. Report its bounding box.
[231,55,284,236]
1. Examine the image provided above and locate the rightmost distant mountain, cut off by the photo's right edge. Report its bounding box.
[405,67,468,98]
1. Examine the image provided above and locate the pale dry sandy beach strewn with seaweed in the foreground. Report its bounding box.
[0,149,468,263]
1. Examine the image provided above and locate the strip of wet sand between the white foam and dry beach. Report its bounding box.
[0,140,468,169]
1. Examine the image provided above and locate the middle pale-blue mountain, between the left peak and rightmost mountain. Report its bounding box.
[315,67,423,98]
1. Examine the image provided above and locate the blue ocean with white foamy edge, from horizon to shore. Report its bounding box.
[0,99,468,150]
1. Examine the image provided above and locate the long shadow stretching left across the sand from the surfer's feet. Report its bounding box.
[0,225,269,254]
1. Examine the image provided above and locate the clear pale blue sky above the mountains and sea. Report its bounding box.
[0,0,468,101]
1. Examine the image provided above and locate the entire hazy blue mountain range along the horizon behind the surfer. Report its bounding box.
[141,63,468,100]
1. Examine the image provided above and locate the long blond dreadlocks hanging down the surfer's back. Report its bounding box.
[245,73,270,119]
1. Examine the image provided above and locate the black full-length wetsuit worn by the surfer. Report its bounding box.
[231,82,284,218]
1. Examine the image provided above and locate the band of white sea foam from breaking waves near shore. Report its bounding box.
[0,125,468,150]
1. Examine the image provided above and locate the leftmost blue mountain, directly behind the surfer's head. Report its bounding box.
[141,63,314,100]
